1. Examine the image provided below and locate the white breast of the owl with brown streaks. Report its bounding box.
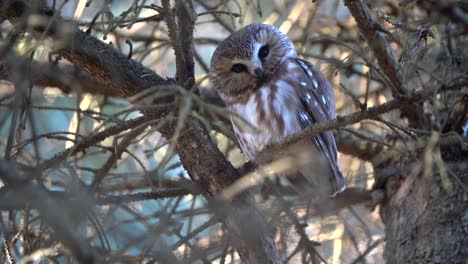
[229,80,301,160]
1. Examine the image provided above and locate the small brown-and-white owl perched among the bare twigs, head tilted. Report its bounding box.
[210,24,345,196]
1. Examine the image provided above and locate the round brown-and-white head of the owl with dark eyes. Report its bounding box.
[210,24,296,101]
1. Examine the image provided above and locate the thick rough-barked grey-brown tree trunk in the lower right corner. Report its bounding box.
[376,147,468,264]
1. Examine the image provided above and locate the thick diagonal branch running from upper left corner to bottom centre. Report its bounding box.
[0,0,282,263]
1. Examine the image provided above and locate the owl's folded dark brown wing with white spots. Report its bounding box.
[295,59,346,195]
